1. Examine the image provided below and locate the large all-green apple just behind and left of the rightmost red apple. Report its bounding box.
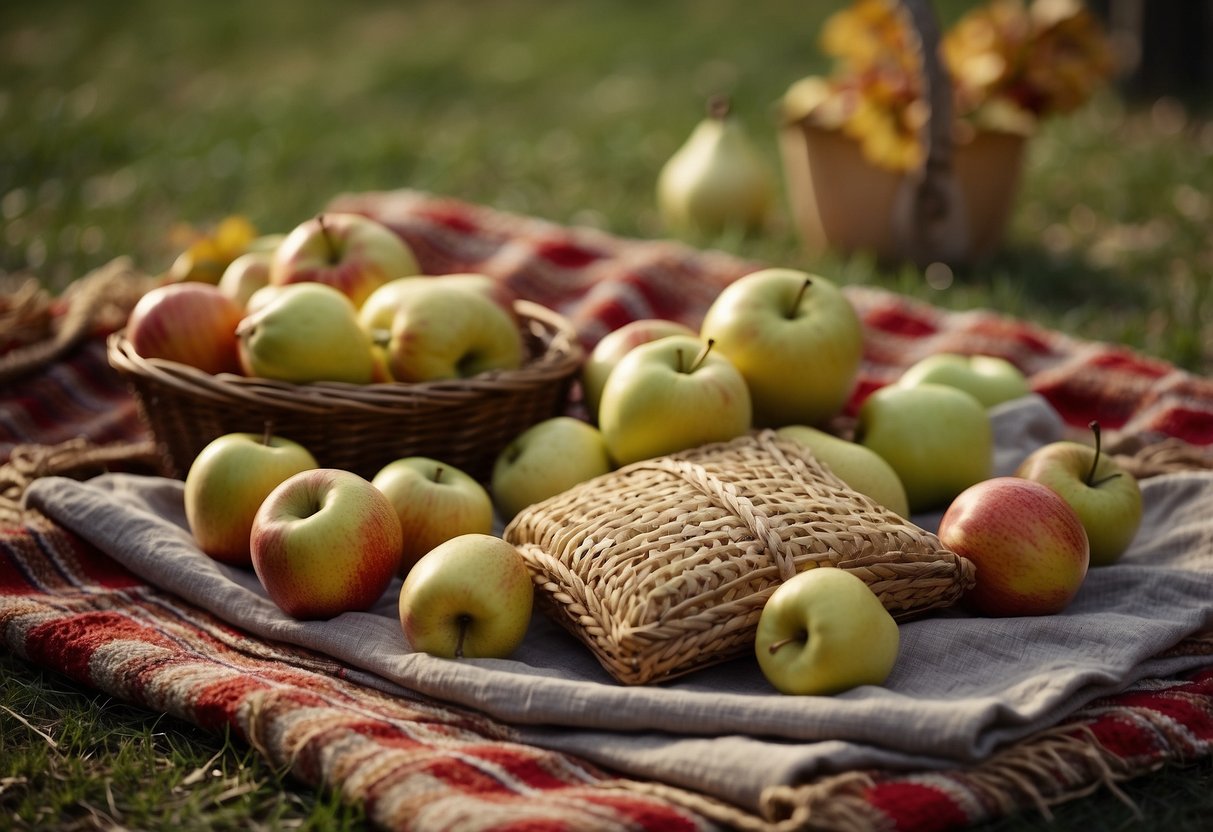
[856,383,993,512]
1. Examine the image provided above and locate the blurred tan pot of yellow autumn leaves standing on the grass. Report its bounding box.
[781,0,1115,263]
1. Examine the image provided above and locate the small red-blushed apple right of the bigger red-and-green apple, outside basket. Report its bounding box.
[371,456,492,574]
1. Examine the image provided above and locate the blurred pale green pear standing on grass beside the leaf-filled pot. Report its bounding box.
[657,96,775,238]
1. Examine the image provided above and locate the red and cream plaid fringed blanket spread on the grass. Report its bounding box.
[0,192,1213,830]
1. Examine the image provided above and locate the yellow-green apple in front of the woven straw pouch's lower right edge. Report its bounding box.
[754,566,901,695]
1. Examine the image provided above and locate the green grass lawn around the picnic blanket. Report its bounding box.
[0,0,1213,830]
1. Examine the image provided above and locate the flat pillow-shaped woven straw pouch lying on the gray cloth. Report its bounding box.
[505,431,974,684]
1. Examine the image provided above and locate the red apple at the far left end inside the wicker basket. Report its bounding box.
[126,281,244,375]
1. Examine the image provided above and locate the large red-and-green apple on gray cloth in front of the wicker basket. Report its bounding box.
[249,468,403,619]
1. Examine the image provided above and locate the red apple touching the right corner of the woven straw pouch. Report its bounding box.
[939,477,1089,616]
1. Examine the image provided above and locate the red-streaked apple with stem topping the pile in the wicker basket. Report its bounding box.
[269,212,420,306]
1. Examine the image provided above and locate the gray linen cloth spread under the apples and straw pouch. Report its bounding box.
[27,395,1213,810]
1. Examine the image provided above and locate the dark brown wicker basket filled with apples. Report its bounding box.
[107,301,583,480]
